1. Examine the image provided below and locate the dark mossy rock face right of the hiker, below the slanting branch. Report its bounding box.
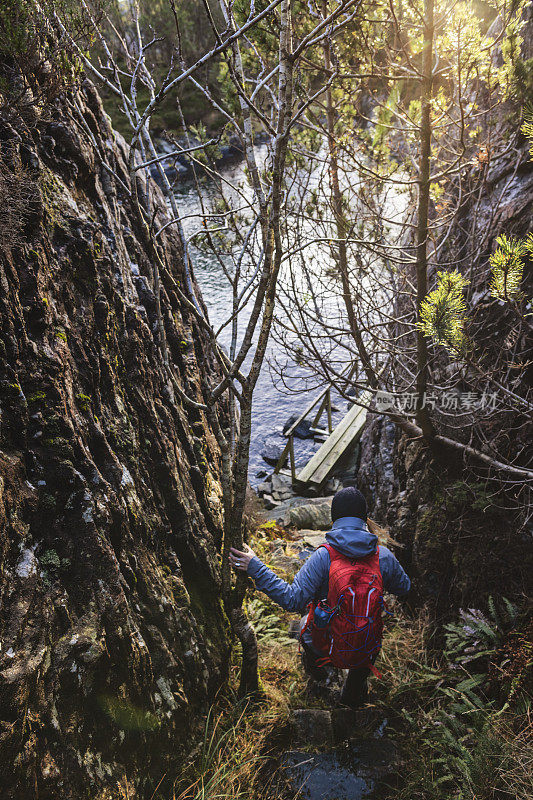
[358,415,533,628]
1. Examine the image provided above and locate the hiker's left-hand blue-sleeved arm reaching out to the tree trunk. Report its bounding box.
[230,547,330,611]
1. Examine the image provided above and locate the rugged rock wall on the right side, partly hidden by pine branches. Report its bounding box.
[357,56,533,621]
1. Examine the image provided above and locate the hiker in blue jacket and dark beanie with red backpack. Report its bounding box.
[230,486,411,709]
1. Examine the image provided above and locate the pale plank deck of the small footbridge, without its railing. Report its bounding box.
[296,391,372,486]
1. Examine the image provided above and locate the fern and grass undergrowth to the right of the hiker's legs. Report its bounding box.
[375,600,533,800]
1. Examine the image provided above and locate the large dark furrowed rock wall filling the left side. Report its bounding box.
[0,80,229,800]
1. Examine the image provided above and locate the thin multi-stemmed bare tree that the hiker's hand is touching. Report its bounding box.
[56,0,370,694]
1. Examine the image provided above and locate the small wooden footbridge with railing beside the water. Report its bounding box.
[274,387,372,489]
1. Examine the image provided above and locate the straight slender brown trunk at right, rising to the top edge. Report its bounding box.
[416,0,434,439]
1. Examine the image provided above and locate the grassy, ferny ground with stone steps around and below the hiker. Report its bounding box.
[164,521,533,800]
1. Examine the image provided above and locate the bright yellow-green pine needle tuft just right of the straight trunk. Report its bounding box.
[418,270,468,352]
